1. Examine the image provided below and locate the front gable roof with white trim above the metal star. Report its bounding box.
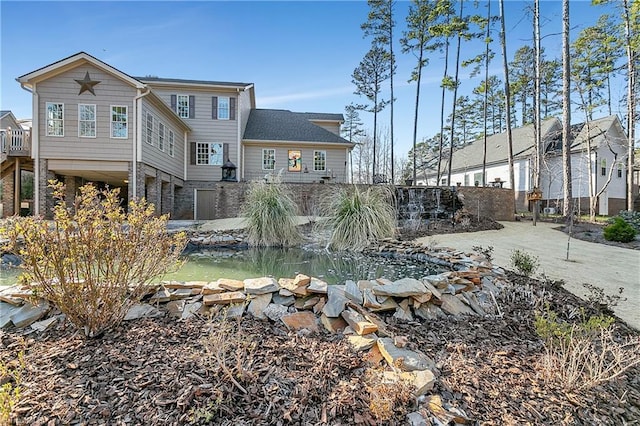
[16,52,146,89]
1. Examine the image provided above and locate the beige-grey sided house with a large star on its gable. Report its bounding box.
[2,52,353,219]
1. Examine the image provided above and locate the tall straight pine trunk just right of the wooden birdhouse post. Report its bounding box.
[562,0,573,220]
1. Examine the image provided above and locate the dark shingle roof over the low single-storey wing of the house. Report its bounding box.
[243,109,349,144]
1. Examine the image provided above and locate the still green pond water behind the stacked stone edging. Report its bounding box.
[0,247,443,286]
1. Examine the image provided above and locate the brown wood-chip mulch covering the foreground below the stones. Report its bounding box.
[0,220,640,425]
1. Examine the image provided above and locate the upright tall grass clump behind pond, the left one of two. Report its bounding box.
[242,178,302,247]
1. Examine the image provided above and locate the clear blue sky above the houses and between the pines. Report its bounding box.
[0,0,624,159]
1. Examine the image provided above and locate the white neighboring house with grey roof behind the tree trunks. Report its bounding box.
[418,115,627,215]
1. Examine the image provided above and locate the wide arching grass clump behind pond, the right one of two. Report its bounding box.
[324,186,396,251]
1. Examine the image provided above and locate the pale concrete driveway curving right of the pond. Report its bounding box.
[417,222,640,330]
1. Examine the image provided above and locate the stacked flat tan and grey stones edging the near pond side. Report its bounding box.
[0,238,507,424]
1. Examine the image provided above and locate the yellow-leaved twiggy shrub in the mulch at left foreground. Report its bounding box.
[3,181,186,337]
